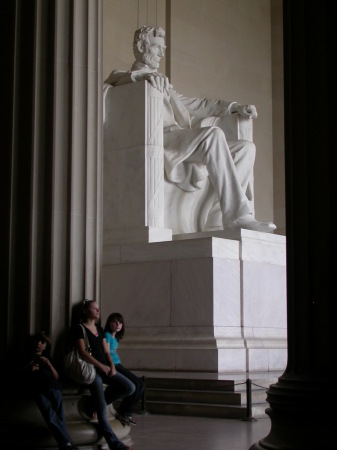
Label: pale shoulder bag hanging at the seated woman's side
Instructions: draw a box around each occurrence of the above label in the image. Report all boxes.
[64,325,96,384]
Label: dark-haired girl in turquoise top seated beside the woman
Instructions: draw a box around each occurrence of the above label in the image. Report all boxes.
[104,313,145,425]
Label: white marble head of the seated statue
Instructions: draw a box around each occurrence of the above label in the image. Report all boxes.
[133,26,166,69]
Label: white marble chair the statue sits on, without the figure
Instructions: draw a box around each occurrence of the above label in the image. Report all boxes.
[103,81,253,244]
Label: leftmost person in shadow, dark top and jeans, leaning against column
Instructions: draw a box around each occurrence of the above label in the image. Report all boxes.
[24,331,77,450]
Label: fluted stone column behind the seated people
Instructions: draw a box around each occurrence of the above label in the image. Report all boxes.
[0,0,128,449]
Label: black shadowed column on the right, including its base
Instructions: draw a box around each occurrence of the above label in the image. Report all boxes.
[251,0,336,450]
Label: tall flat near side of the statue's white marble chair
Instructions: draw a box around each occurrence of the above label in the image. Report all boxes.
[103,83,172,244]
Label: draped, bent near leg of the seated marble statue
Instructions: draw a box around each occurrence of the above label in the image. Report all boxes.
[164,127,276,233]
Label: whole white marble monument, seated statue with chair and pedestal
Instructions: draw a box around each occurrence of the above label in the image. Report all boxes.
[101,29,286,373]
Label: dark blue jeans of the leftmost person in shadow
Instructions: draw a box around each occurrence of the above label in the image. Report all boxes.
[35,388,71,448]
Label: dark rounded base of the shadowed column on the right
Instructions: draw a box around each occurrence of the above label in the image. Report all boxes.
[249,377,336,450]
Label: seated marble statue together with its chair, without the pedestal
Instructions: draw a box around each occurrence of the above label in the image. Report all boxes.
[104,27,275,243]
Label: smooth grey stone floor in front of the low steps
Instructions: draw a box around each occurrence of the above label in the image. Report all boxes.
[115,413,270,450]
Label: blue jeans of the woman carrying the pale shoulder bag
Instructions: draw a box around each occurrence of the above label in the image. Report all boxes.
[88,372,135,449]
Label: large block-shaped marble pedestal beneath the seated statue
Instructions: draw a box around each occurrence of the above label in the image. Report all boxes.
[101,230,287,373]
